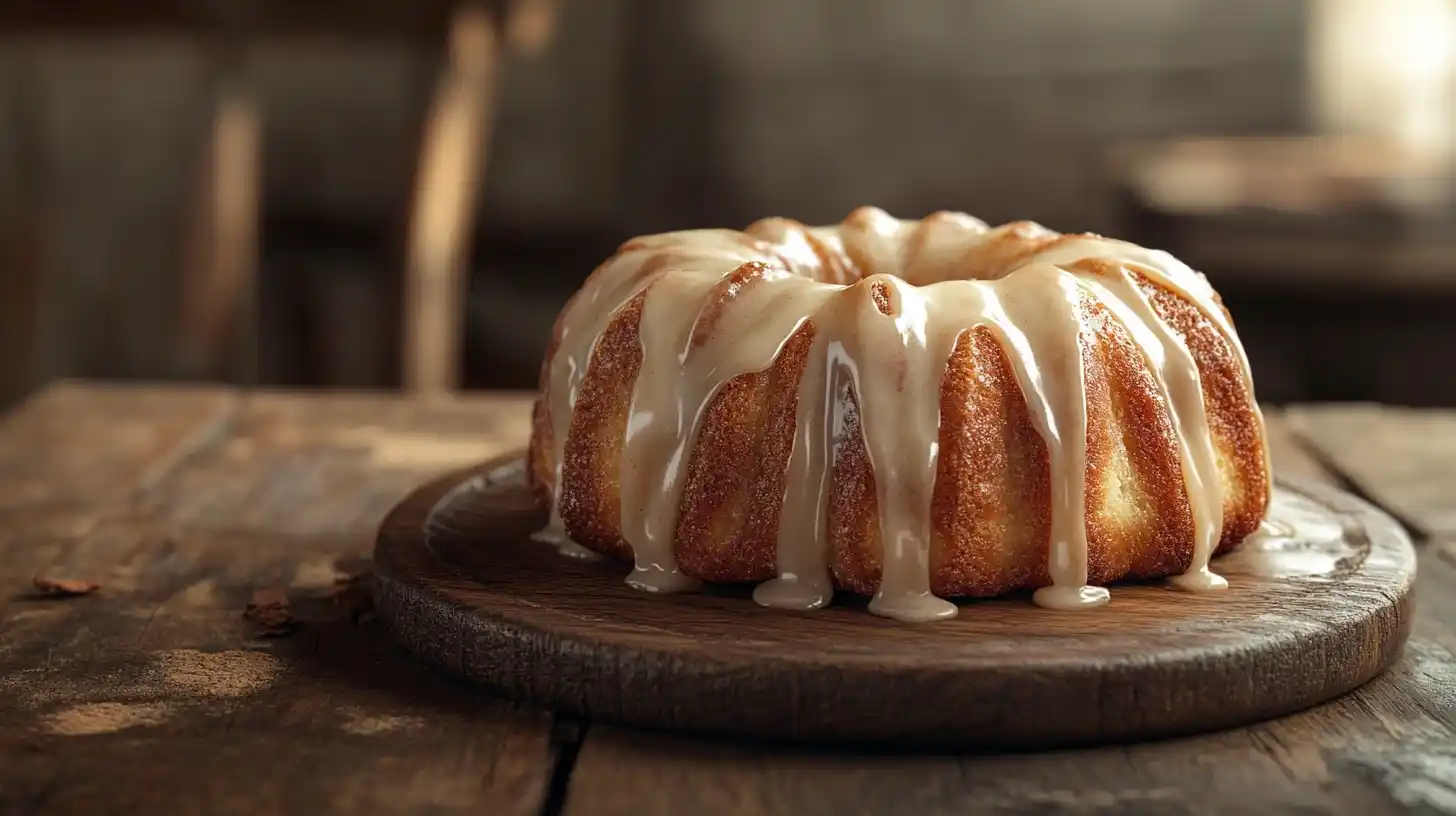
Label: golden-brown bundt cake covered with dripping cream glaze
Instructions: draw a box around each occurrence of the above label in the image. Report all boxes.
[529,207,1271,621]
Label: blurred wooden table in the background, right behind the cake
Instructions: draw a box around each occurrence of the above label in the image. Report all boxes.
[1109,137,1456,405]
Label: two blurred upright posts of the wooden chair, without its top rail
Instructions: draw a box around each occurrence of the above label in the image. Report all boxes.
[168,0,558,396]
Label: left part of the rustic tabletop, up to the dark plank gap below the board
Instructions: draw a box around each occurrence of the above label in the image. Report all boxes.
[0,386,556,815]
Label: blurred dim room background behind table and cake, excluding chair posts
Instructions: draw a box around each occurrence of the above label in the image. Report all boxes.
[0,0,1456,404]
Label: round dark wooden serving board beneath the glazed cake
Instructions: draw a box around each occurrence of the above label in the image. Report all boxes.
[376,451,1415,748]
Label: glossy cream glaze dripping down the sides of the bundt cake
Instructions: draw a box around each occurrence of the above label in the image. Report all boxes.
[536,207,1268,621]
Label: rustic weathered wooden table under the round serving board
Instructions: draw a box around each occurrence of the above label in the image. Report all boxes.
[0,385,1456,816]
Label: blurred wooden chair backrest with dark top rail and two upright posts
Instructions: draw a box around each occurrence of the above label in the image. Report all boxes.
[0,0,559,395]
